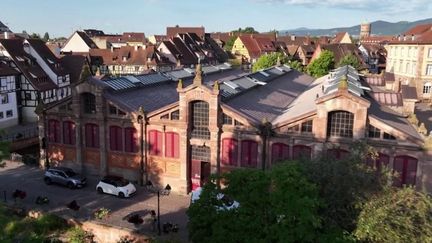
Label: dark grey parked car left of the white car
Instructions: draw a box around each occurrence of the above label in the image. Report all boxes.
[44,167,87,189]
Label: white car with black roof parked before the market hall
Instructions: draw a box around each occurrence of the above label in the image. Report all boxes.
[96,176,136,198]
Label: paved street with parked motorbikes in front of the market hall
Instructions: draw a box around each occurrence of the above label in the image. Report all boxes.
[0,162,190,241]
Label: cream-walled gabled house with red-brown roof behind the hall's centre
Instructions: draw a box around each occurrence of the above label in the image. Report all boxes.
[231,35,276,63]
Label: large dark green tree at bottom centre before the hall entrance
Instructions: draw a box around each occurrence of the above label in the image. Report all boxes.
[187,162,321,242]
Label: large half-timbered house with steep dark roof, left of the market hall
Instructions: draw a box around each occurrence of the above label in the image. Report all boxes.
[0,39,85,123]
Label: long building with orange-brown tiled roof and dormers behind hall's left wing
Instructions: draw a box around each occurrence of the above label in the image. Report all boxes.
[89,45,175,75]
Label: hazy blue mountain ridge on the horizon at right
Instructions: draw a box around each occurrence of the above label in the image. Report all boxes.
[279,18,432,36]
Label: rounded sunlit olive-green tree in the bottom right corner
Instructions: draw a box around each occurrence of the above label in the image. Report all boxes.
[355,187,432,243]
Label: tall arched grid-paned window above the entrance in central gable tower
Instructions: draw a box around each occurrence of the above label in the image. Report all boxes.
[191,100,210,139]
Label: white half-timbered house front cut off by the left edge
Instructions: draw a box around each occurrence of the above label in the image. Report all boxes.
[0,60,20,129]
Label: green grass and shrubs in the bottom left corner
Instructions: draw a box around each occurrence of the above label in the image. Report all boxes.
[0,203,92,243]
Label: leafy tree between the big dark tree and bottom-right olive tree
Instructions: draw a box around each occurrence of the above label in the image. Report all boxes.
[302,142,391,233]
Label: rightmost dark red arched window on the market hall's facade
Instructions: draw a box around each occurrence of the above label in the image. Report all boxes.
[393,155,418,186]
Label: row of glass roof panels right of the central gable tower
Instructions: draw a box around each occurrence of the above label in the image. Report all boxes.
[220,65,291,98]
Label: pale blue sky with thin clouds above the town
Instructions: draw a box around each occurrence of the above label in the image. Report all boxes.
[0,0,432,37]
